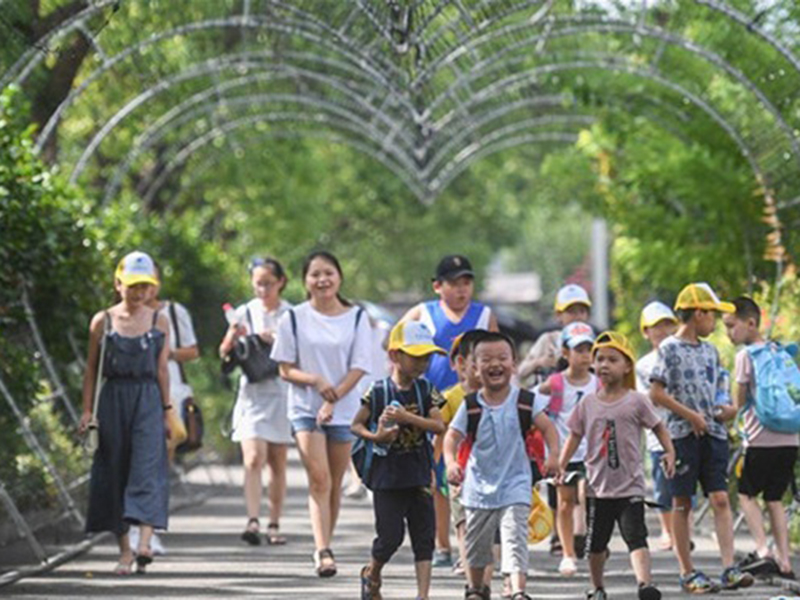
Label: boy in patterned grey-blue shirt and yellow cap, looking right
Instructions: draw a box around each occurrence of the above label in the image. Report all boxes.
[650,283,753,594]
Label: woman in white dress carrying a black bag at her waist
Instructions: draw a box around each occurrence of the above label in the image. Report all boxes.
[219,258,292,546]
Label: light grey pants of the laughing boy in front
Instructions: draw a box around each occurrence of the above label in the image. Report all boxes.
[464,504,531,573]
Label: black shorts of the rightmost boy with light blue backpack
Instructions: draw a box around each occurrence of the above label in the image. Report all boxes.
[739,446,797,502]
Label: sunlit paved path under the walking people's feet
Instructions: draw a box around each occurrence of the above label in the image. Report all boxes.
[0,454,796,600]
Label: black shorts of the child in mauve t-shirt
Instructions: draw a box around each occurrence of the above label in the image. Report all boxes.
[586,496,647,554]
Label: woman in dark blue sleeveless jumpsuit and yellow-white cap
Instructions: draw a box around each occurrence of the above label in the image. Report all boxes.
[81,252,169,575]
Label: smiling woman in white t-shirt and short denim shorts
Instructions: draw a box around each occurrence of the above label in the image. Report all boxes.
[272,251,372,577]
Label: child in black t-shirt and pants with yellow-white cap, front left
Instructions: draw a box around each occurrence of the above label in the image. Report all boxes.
[351,321,446,600]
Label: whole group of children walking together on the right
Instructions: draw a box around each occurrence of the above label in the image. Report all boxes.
[352,256,798,600]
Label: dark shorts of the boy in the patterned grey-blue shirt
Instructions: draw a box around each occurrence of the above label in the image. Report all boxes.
[669,434,730,499]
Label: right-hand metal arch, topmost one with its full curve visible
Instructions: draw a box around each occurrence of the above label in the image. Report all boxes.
[430,18,800,165]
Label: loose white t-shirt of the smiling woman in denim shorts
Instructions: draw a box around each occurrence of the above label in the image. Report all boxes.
[272,302,373,426]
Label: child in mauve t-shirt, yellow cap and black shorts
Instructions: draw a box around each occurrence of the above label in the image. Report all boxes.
[559,331,675,600]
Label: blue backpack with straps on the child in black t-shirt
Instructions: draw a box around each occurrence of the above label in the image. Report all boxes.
[351,377,433,489]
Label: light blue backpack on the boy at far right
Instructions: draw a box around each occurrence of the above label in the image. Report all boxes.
[747,341,800,433]
